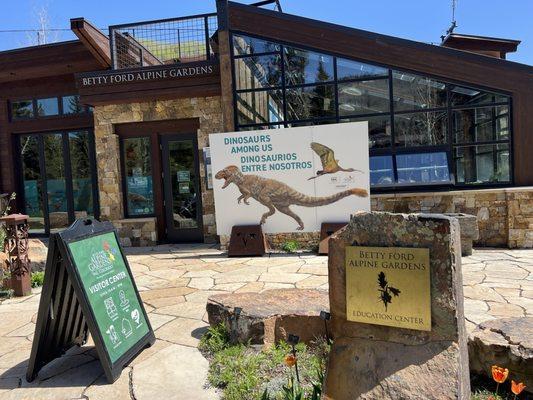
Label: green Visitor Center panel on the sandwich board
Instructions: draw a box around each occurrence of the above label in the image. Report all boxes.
[68,232,149,363]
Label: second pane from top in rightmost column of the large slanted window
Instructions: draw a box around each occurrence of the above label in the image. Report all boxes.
[452,106,509,143]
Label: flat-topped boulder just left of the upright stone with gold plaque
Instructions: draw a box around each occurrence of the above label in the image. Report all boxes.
[206,289,329,346]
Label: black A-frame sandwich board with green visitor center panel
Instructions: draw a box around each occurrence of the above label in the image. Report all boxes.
[26,219,155,383]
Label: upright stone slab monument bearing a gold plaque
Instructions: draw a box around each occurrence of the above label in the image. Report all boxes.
[324,212,470,400]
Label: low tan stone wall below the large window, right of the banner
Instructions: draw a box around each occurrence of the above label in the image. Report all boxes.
[371,187,533,248]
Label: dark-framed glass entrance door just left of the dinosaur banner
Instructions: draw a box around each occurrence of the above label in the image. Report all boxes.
[161,134,204,242]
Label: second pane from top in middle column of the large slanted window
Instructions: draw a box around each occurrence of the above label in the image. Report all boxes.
[338,79,390,116]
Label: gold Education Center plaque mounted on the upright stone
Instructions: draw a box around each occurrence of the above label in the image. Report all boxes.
[346,246,431,331]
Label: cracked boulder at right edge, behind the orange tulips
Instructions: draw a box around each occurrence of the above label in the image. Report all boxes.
[468,317,533,392]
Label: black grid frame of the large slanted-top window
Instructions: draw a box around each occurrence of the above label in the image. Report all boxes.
[230,30,514,193]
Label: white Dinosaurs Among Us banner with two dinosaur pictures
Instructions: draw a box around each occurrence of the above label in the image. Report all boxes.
[209,122,370,235]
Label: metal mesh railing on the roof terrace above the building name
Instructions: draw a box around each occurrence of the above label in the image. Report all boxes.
[109,14,217,69]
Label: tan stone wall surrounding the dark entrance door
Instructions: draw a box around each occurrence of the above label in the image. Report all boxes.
[94,96,223,244]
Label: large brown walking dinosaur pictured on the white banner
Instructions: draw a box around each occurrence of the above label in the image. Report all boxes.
[215,165,368,230]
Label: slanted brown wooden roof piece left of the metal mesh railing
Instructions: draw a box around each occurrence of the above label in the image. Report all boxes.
[70,18,111,68]
